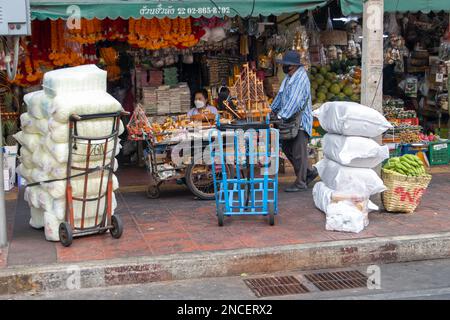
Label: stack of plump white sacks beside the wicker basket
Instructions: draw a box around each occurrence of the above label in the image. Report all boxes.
[313,102,392,233]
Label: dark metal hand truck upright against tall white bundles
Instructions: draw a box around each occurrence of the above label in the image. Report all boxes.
[59,111,129,247]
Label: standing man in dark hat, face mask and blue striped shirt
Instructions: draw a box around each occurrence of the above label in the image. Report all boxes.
[271,51,318,192]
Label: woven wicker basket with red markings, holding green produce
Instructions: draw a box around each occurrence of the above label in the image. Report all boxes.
[381,169,431,213]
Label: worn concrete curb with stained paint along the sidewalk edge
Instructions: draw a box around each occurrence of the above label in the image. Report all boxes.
[0,232,450,295]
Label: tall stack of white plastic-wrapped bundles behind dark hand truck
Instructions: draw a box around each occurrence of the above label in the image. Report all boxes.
[15,65,124,241]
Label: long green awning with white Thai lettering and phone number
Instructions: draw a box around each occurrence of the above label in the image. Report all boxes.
[31,0,327,20]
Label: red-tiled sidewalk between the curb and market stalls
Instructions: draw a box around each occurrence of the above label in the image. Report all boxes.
[0,166,450,292]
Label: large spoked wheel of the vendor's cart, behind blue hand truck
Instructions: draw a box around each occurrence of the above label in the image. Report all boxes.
[185,164,230,200]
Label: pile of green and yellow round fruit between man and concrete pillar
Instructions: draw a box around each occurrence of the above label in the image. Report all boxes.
[309,62,361,104]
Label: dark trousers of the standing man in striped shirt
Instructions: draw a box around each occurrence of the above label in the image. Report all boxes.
[281,130,313,188]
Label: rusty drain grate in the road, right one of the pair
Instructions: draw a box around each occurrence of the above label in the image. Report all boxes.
[305,270,367,291]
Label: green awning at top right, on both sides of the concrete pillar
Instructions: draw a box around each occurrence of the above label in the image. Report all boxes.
[340,0,450,16]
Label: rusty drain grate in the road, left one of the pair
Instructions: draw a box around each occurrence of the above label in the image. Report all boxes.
[244,276,309,298]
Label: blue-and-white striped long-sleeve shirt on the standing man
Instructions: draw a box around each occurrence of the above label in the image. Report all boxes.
[271,67,313,137]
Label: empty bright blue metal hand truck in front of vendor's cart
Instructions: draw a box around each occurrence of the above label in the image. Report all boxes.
[209,118,279,226]
